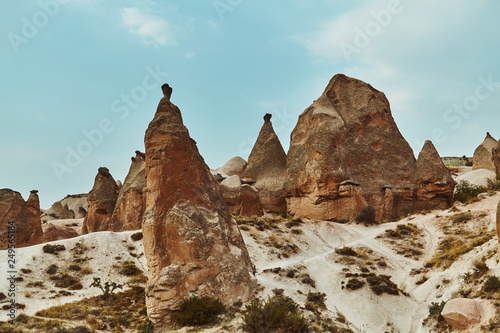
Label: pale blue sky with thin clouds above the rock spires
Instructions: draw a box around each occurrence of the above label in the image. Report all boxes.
[0,0,500,208]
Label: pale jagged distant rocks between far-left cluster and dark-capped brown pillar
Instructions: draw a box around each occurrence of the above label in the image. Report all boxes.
[42,193,88,223]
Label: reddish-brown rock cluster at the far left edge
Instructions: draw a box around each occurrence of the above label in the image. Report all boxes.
[0,189,43,250]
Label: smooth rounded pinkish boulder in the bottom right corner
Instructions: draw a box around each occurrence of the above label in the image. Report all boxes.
[441,298,484,330]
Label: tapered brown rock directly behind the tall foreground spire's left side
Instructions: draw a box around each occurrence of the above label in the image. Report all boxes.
[106,151,146,231]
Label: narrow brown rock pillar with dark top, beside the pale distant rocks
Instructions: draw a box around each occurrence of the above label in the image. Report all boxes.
[82,167,119,234]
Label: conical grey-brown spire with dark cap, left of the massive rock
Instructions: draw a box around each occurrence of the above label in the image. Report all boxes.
[245,113,286,213]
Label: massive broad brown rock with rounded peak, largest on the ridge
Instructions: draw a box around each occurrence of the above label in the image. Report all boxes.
[284,74,416,220]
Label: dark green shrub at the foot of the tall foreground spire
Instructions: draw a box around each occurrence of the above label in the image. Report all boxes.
[172,296,226,327]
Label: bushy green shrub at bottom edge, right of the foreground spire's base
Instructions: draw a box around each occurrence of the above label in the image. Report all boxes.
[243,295,309,333]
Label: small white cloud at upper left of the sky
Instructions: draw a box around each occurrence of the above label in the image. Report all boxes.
[121,8,177,46]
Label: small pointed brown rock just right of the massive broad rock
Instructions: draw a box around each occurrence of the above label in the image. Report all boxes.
[415,140,455,209]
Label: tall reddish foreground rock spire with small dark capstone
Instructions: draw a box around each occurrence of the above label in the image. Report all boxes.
[143,84,255,331]
